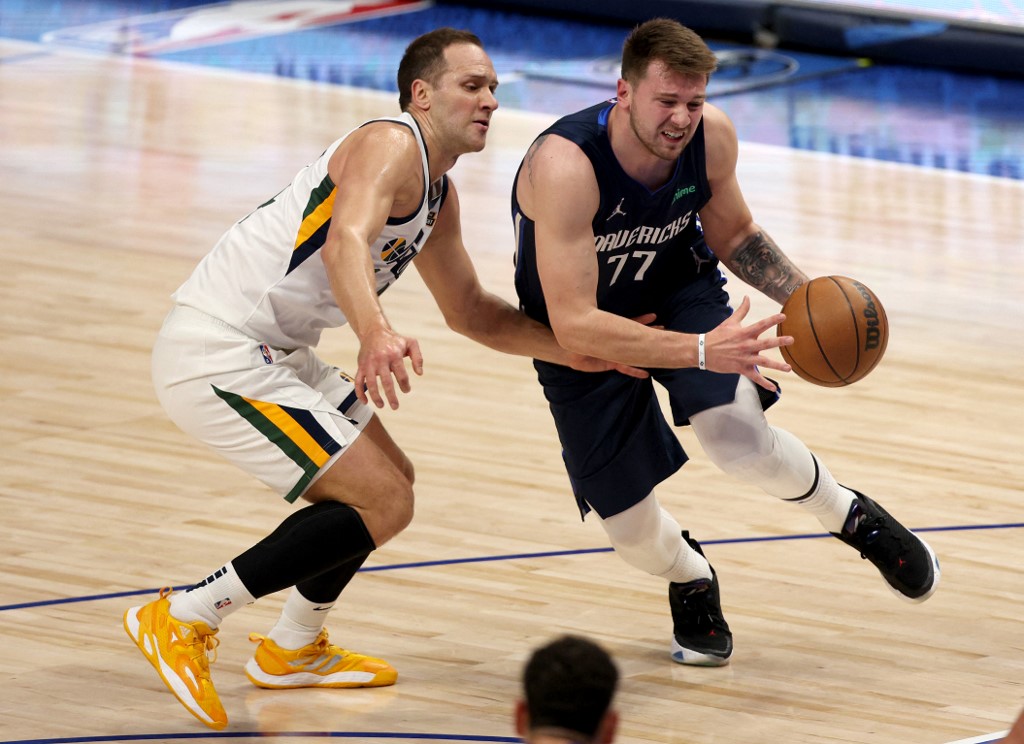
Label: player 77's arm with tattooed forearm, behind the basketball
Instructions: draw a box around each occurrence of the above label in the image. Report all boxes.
[700,104,808,304]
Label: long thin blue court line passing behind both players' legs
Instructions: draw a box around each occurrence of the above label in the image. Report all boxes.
[0,522,1024,614]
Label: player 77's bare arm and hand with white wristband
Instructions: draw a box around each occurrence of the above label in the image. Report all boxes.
[517,135,787,388]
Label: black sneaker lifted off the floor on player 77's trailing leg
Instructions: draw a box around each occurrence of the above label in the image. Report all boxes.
[833,491,941,602]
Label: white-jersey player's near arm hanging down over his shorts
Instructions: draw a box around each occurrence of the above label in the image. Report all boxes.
[321,123,423,408]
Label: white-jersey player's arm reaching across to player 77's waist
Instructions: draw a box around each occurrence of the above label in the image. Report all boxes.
[413,178,647,377]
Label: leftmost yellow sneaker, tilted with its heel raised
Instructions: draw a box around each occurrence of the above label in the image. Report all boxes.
[125,588,227,730]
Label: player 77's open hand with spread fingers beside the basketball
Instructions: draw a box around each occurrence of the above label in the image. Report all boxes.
[705,297,793,392]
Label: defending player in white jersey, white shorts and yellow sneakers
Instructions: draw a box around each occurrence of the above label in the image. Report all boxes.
[124,29,675,729]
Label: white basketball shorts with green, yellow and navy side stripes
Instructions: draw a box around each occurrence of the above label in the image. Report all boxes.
[153,305,374,501]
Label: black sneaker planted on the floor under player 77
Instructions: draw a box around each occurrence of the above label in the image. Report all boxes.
[669,531,732,666]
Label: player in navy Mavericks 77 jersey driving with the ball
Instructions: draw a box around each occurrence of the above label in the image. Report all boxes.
[512,18,939,665]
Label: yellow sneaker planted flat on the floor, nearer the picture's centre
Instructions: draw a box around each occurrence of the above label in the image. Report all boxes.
[246,630,398,690]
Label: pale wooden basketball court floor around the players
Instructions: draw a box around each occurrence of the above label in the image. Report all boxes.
[0,43,1024,744]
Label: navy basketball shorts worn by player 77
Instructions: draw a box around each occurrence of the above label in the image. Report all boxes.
[534,271,777,518]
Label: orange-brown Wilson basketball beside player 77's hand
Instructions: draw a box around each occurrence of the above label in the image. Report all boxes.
[778,276,889,388]
